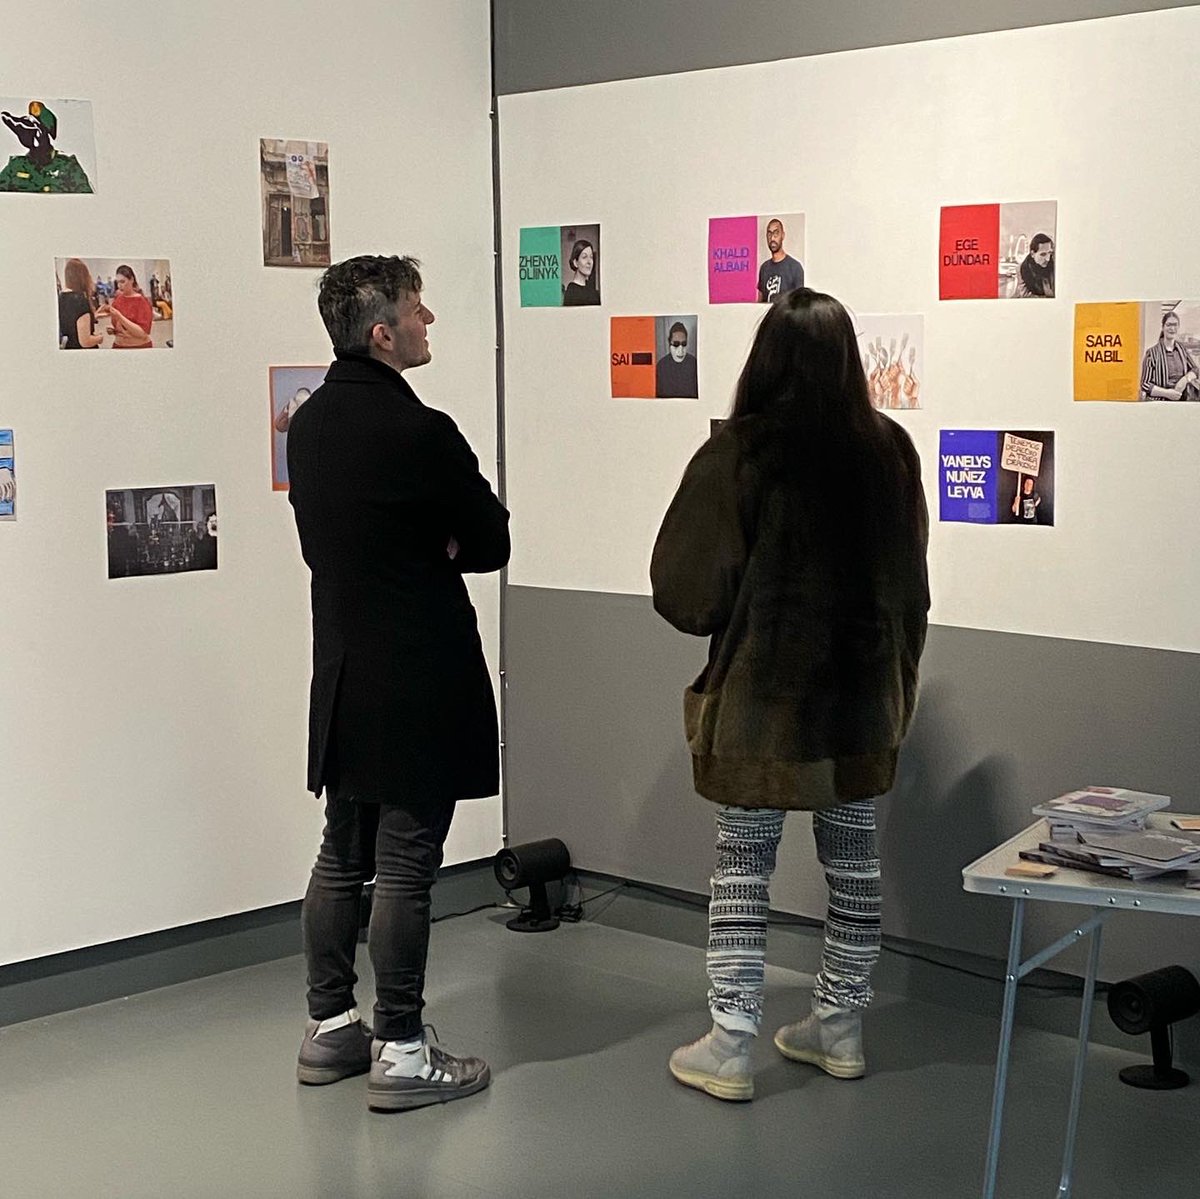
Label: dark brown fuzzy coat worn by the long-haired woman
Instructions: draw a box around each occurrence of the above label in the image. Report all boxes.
[650,414,929,810]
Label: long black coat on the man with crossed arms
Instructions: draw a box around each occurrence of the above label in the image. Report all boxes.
[288,354,509,803]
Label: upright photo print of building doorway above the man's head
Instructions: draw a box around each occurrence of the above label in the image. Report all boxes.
[258,137,332,266]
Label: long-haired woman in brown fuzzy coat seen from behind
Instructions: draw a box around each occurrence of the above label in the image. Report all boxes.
[650,288,929,1099]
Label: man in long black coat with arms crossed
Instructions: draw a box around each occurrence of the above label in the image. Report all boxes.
[288,257,509,1110]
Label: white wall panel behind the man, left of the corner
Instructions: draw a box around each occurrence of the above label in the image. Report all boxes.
[0,0,500,964]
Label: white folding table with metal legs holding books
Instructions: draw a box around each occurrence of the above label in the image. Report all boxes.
[962,813,1200,1199]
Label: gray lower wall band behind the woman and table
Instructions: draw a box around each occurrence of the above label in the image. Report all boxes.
[506,587,1200,979]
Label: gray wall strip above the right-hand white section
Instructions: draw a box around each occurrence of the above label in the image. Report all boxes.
[493,0,1190,96]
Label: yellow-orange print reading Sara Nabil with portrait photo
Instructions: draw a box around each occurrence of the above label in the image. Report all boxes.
[1074,300,1200,403]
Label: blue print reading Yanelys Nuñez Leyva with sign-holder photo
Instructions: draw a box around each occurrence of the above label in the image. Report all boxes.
[937,428,1055,526]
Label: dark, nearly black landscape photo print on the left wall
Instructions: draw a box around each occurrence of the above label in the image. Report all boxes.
[104,484,217,578]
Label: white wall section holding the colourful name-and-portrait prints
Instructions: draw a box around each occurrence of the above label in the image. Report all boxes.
[500,7,1200,651]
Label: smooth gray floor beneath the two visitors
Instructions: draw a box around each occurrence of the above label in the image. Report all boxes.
[0,912,1200,1199]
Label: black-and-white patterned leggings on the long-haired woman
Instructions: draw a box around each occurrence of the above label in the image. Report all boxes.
[707,799,881,1032]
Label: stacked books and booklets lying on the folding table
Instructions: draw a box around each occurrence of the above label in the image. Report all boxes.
[1021,787,1200,879]
